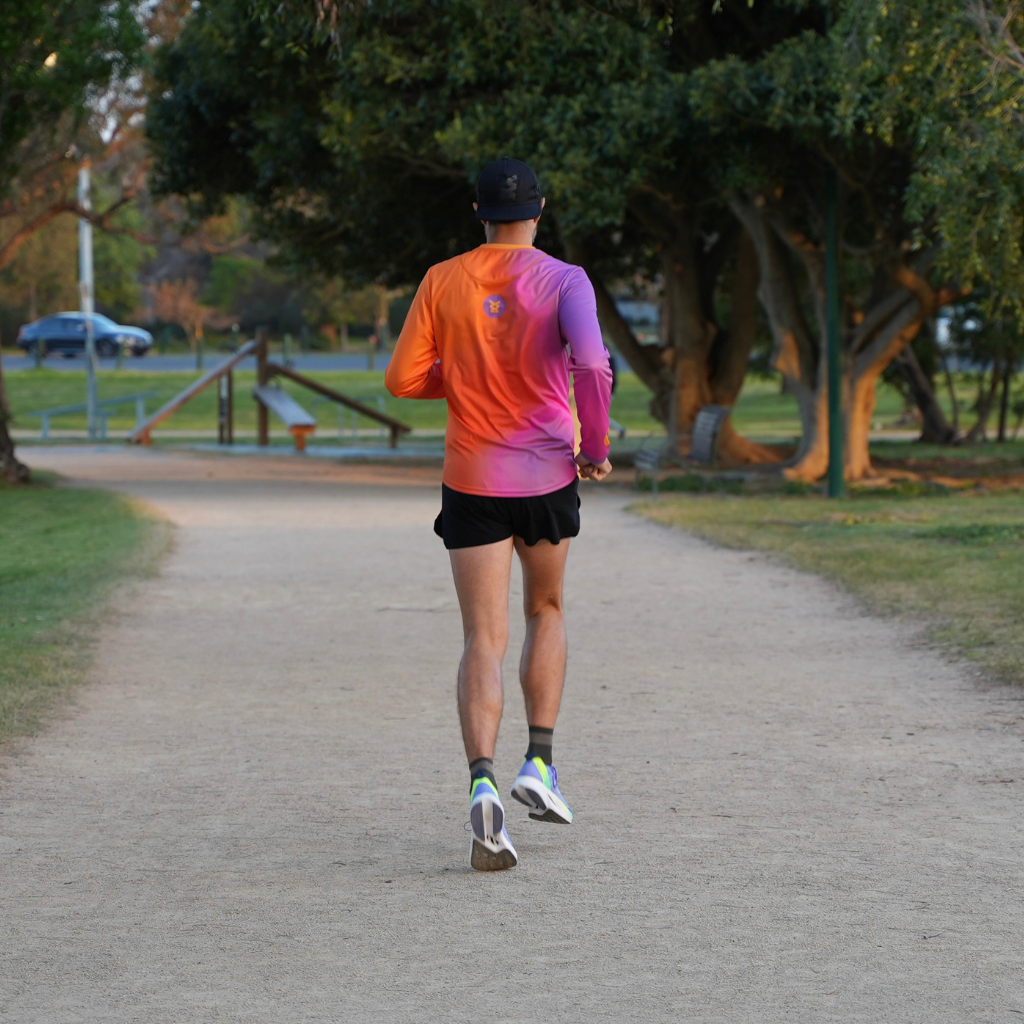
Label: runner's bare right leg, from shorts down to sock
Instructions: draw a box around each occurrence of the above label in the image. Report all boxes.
[515,538,569,729]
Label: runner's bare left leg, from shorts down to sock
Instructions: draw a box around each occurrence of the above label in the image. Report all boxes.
[449,539,512,762]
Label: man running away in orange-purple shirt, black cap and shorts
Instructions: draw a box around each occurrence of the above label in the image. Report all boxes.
[384,160,611,871]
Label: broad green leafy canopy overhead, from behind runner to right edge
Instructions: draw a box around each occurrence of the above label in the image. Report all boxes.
[150,0,1021,299]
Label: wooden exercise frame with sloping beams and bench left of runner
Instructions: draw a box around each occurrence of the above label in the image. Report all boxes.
[127,328,412,452]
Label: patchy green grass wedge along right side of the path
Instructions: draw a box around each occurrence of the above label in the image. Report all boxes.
[635,494,1024,683]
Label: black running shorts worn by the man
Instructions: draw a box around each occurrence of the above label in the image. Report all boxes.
[434,480,580,550]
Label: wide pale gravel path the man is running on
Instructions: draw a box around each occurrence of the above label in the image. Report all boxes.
[0,452,1024,1024]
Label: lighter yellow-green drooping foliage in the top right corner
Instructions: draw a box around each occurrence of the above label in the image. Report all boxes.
[834,0,1024,308]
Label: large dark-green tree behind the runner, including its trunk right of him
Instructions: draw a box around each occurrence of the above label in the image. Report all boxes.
[148,0,815,461]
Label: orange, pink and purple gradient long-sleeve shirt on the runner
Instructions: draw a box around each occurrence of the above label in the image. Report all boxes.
[384,244,611,498]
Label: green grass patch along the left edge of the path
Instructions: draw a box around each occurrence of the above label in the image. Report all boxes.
[0,476,169,742]
